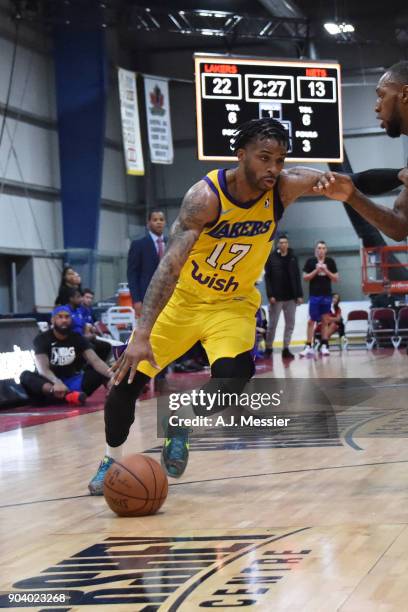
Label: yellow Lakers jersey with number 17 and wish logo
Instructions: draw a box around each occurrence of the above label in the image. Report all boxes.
[177,169,283,302]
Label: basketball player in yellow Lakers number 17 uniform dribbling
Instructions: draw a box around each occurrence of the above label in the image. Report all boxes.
[89,119,323,495]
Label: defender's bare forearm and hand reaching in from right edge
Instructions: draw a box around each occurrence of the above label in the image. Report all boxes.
[314,171,408,241]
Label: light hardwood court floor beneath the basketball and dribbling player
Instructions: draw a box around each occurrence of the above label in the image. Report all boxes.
[0,351,408,612]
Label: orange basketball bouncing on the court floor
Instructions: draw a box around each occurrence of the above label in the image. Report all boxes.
[103,455,168,516]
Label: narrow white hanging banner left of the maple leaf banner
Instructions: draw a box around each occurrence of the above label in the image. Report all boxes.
[118,68,144,175]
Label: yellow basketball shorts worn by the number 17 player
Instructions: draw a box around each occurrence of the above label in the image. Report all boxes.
[137,289,258,378]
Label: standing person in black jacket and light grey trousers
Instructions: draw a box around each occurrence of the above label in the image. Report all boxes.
[265,236,303,359]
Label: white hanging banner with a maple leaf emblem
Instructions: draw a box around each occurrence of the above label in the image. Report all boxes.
[144,76,173,164]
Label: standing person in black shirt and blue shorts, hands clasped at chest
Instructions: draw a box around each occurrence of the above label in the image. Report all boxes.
[300,240,339,357]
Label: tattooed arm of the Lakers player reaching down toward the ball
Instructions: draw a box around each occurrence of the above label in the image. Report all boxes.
[112,181,219,384]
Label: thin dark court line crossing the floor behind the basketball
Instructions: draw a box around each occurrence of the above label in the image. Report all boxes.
[0,459,408,510]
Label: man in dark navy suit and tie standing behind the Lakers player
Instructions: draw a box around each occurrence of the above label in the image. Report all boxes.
[127,210,166,317]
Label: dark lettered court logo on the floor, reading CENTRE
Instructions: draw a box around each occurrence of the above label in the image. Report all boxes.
[7,528,311,612]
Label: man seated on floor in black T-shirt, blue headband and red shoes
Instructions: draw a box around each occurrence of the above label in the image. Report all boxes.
[20,306,111,406]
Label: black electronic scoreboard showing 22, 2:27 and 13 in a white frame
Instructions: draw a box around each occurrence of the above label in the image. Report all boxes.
[194,53,343,162]
